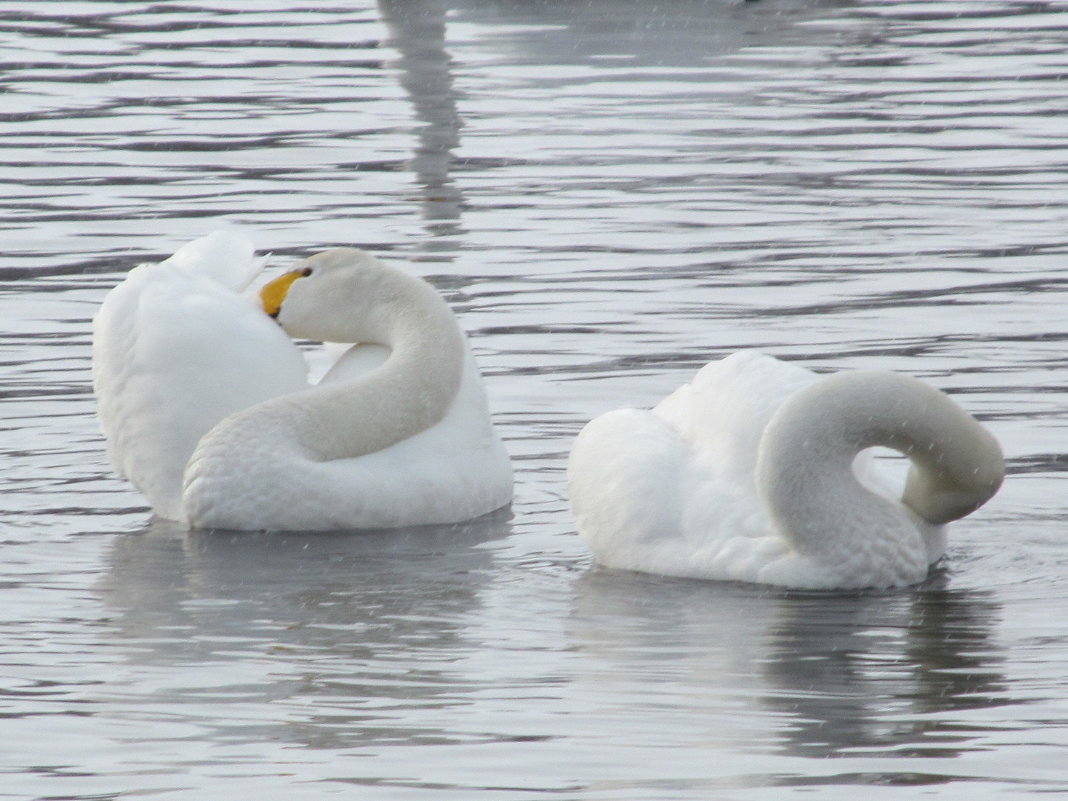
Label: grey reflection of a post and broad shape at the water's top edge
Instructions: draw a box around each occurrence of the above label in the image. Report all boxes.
[378,0,852,261]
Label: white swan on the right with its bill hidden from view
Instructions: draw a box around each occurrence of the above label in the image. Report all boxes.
[568,351,1004,588]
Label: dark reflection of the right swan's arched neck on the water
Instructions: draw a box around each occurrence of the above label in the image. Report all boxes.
[763,581,1012,757]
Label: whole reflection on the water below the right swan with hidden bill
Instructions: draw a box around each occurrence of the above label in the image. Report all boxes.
[570,569,1011,767]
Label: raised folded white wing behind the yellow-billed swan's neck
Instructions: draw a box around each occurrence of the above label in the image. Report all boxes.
[93,263,307,519]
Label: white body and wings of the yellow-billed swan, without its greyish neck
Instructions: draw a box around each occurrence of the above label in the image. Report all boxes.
[93,232,512,530]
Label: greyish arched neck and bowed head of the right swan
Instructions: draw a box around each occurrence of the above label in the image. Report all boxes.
[757,371,1004,559]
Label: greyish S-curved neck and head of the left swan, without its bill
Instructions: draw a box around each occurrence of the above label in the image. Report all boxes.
[239,257,466,461]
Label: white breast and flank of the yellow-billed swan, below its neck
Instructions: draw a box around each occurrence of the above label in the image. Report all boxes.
[179,357,512,531]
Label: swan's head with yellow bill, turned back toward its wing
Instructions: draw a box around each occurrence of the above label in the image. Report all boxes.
[260,248,390,342]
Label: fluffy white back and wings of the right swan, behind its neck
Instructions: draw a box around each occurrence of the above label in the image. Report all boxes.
[568,351,803,581]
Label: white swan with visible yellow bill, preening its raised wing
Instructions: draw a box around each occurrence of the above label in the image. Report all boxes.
[93,232,513,531]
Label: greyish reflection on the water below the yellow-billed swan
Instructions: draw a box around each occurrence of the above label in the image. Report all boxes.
[97,513,512,749]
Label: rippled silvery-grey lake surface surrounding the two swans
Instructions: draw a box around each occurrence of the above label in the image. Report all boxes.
[0,0,1068,801]
